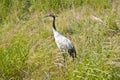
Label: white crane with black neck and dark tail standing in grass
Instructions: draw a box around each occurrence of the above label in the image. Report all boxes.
[45,13,76,61]
